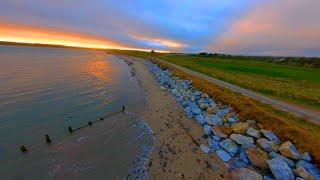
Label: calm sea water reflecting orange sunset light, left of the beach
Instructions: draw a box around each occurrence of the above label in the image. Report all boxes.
[0,46,153,179]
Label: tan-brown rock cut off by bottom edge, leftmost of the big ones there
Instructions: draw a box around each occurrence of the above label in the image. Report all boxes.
[231,168,262,180]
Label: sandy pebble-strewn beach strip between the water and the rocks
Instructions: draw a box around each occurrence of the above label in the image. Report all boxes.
[129,58,229,179]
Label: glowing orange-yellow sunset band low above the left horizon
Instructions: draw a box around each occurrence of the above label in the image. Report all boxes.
[0,22,165,51]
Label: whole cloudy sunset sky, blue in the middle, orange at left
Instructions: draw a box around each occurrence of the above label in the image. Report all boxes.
[0,0,320,56]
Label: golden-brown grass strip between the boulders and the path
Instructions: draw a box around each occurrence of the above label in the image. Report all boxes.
[154,61,320,164]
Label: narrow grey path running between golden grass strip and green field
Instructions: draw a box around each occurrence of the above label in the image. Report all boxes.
[149,58,320,124]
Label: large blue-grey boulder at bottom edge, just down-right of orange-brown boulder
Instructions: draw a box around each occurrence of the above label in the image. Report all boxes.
[268,158,295,180]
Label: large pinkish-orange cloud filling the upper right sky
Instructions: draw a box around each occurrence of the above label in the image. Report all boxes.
[208,0,320,55]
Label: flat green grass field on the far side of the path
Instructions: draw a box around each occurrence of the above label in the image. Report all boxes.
[109,51,320,110]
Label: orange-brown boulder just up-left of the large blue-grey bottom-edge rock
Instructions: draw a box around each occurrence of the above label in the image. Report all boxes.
[246,148,268,169]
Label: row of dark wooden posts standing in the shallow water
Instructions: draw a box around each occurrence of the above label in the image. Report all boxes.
[20,106,125,153]
